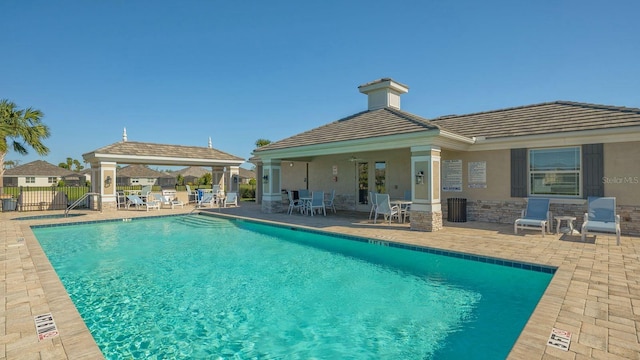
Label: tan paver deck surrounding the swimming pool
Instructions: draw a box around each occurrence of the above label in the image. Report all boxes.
[0,203,640,359]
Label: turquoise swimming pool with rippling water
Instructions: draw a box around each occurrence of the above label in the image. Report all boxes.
[34,215,553,359]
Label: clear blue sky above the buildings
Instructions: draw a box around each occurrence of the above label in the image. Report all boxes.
[5,0,640,168]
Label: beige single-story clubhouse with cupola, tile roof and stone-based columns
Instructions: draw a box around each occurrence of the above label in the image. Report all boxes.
[252,78,640,234]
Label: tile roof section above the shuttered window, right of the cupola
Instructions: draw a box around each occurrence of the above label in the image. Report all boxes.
[431,101,640,138]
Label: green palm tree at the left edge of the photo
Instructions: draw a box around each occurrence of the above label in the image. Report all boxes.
[0,99,51,193]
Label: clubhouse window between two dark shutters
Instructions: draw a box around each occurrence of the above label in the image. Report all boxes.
[529,147,581,196]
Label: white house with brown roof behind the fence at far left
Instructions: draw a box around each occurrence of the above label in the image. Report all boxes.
[4,160,85,186]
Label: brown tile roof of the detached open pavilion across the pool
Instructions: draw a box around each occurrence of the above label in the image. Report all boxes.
[83,141,244,161]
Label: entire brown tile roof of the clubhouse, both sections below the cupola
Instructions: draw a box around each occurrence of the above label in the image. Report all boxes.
[254,101,640,155]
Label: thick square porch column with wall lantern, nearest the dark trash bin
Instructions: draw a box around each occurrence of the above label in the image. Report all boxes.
[410,146,442,231]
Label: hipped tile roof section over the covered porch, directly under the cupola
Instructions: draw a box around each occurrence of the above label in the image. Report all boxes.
[254,107,438,153]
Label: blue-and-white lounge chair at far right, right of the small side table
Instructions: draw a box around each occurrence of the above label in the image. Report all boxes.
[581,197,620,245]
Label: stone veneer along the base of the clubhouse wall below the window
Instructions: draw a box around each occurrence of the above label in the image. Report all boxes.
[442,200,640,235]
